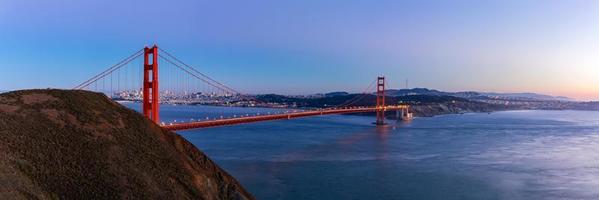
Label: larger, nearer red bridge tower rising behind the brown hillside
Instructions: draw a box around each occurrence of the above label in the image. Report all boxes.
[143,45,160,123]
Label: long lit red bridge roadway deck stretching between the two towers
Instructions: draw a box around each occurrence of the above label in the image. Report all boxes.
[162,105,408,131]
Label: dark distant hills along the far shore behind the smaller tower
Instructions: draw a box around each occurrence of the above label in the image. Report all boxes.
[257,88,599,116]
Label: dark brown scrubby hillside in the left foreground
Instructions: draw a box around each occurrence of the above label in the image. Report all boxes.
[0,90,253,199]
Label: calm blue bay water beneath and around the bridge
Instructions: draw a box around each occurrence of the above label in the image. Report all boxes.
[123,103,599,200]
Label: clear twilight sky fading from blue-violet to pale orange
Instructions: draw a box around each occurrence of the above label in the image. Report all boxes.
[0,0,599,100]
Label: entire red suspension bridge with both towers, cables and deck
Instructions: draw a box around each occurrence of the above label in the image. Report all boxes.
[74,45,411,131]
